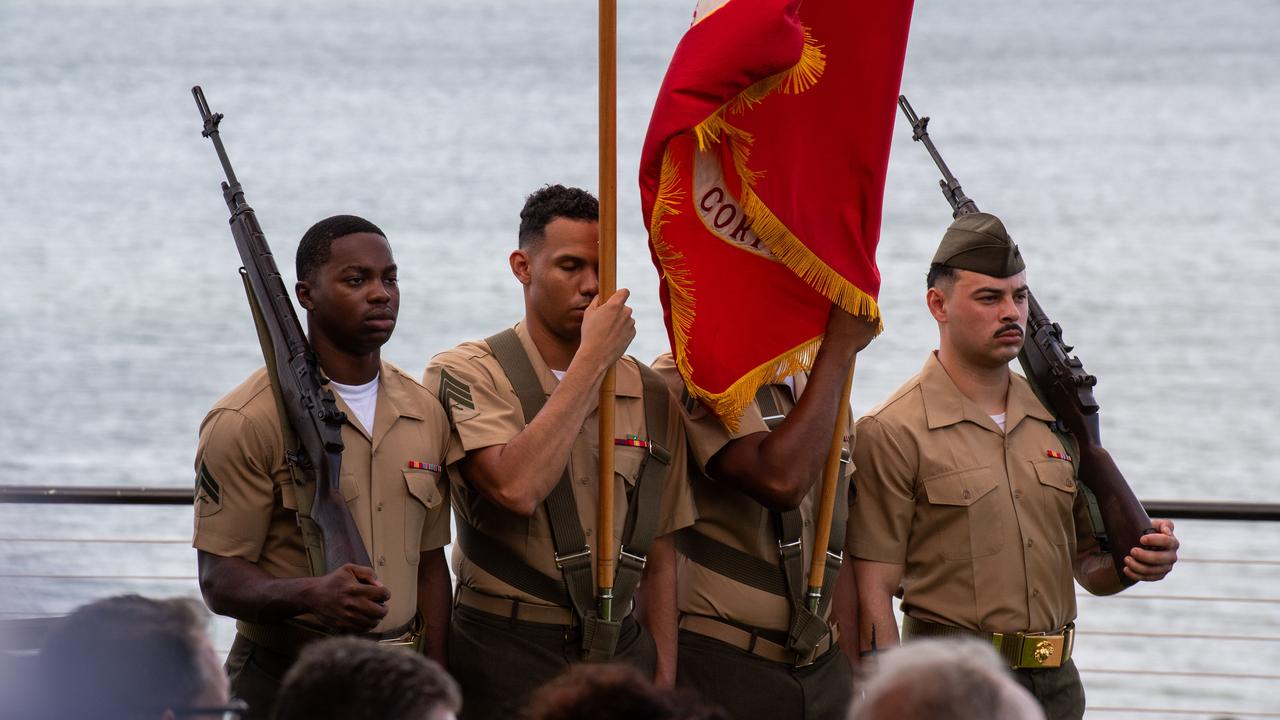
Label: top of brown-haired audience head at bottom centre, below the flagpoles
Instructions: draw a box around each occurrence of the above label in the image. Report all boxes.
[524,662,728,720]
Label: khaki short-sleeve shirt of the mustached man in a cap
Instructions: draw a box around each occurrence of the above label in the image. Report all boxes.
[847,354,1097,633]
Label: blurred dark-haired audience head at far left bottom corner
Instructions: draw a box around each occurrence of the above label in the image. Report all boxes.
[40,594,209,719]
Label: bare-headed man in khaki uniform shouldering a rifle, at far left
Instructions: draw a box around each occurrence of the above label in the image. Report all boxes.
[193,215,451,717]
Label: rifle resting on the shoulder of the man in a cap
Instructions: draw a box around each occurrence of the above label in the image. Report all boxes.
[897,95,1156,584]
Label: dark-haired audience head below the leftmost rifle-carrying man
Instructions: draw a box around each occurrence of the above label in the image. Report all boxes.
[273,638,462,720]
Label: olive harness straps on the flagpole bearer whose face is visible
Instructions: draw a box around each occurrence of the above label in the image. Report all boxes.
[458,328,672,660]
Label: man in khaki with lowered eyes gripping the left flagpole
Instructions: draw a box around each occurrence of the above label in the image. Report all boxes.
[425,186,696,720]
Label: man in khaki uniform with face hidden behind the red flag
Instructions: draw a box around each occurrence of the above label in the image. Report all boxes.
[654,309,874,720]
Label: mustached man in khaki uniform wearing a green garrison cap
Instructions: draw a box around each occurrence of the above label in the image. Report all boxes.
[849,213,1178,719]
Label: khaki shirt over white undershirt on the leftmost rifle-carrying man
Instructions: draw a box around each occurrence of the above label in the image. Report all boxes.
[192,363,449,632]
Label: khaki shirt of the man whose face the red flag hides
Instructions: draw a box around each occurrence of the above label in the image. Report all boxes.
[653,352,850,630]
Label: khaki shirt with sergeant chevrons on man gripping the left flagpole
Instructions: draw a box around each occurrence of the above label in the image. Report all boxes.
[424,323,698,605]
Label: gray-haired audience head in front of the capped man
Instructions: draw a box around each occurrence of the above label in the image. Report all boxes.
[849,639,1044,720]
